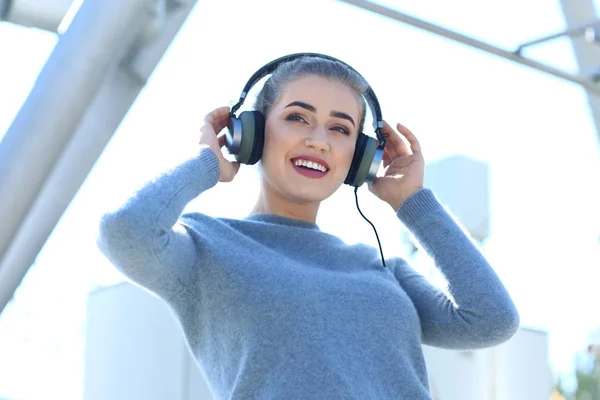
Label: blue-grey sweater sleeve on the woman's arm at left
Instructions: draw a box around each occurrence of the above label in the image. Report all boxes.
[97,147,219,299]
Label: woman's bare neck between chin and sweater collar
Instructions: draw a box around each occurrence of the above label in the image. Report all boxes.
[250,182,320,224]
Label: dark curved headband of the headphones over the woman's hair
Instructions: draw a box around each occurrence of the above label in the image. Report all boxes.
[231,53,386,150]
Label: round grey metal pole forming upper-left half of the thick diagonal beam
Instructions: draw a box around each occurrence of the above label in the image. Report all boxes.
[0,0,154,311]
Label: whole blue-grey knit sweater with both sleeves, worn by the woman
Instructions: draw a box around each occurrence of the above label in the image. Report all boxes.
[98,148,519,400]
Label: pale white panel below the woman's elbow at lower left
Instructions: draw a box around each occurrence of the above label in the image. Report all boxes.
[84,283,213,400]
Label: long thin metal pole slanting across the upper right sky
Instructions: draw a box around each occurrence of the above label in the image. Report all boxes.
[339,0,600,95]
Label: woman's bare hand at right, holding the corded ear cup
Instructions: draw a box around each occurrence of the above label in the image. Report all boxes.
[369,121,425,211]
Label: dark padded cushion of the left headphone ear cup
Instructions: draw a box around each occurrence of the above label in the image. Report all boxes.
[235,111,265,165]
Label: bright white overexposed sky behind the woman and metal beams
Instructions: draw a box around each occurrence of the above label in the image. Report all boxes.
[0,0,600,399]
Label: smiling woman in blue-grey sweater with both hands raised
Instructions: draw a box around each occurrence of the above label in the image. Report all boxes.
[99,57,519,400]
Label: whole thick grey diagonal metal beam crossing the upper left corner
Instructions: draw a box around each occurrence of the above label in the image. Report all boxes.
[0,0,202,312]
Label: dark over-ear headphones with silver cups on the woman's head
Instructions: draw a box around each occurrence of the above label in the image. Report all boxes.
[225,53,386,187]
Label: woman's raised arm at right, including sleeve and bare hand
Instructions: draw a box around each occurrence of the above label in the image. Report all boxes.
[370,123,519,348]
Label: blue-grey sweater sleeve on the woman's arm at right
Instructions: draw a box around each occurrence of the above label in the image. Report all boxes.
[394,189,519,349]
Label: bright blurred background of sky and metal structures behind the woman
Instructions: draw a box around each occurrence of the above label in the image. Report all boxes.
[0,0,600,400]
